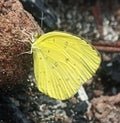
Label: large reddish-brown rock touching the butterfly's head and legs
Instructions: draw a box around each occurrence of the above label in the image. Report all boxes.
[0,0,42,88]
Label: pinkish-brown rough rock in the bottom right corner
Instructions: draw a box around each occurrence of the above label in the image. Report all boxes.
[91,93,120,123]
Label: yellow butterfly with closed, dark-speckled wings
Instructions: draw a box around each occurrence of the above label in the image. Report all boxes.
[32,31,101,100]
